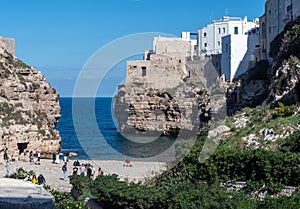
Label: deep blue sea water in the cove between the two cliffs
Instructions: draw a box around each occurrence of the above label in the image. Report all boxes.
[56,98,175,161]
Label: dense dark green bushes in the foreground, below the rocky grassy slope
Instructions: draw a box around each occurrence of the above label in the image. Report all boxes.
[66,121,300,209]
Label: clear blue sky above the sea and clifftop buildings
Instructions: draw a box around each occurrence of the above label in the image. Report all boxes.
[0,0,265,96]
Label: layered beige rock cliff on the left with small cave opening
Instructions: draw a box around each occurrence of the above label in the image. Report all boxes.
[0,48,61,162]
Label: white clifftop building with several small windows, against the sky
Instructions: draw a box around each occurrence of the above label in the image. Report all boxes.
[198,16,256,57]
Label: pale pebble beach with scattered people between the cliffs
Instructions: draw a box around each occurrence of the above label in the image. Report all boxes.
[0,159,166,192]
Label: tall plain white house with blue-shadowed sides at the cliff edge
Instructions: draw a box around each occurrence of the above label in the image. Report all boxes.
[221,27,260,81]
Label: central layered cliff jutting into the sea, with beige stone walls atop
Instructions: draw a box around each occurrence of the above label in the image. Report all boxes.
[114,54,225,138]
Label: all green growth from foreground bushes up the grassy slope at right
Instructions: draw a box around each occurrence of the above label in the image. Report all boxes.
[63,98,300,209]
